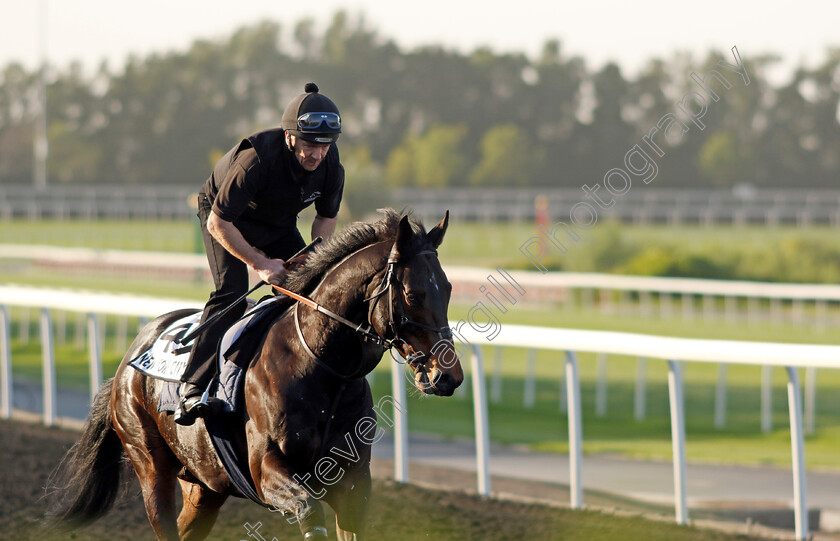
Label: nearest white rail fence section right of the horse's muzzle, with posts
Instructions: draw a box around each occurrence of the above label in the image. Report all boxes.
[450,325,840,539]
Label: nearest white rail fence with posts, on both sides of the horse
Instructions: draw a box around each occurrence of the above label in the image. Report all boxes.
[0,286,840,540]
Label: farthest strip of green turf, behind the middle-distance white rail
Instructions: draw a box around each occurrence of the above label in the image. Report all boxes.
[6,215,840,271]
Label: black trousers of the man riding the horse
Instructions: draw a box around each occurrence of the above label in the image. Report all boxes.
[181,193,306,388]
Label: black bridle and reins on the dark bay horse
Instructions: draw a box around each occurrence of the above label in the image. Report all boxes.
[288,245,452,381]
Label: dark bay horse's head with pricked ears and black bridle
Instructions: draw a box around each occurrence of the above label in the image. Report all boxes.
[371,211,464,396]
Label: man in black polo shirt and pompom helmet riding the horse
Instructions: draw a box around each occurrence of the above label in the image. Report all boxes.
[175,83,344,426]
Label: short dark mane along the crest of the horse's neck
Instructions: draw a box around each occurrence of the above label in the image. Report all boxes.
[283,208,428,295]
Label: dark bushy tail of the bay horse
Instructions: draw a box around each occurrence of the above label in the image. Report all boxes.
[47,378,124,525]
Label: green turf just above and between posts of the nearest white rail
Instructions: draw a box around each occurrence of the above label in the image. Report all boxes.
[3,300,840,467]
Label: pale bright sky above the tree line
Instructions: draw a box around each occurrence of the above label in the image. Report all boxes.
[0,0,840,81]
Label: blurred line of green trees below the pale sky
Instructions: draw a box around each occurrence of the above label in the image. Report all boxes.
[0,11,840,189]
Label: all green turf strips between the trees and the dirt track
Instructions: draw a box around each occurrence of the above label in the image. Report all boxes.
[0,221,840,468]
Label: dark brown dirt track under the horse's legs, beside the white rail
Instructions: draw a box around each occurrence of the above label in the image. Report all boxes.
[0,421,776,541]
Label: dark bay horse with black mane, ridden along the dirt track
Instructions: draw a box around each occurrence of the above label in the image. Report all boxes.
[53,210,463,541]
